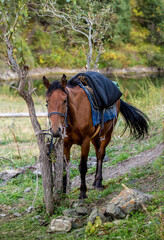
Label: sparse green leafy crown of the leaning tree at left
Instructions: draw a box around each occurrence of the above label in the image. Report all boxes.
[0,0,30,68]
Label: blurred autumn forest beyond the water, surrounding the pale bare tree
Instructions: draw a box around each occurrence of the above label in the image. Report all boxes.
[0,0,164,70]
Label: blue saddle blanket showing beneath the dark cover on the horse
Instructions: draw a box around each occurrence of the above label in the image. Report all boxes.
[78,83,117,126]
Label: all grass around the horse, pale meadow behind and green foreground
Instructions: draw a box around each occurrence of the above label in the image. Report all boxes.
[0,78,164,240]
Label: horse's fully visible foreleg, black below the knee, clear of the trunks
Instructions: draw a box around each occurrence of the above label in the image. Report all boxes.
[79,139,90,199]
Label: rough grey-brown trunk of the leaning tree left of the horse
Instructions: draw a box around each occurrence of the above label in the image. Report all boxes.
[5,36,54,214]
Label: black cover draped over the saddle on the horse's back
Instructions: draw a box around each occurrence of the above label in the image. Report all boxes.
[69,71,122,109]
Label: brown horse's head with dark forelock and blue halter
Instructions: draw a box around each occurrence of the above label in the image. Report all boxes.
[43,74,68,137]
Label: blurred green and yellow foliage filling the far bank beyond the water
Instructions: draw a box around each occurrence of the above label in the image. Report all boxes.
[0,0,164,68]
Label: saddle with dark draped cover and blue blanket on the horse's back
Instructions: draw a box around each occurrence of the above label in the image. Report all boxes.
[68,71,122,129]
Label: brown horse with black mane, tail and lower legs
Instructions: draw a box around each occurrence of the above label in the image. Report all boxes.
[43,74,148,199]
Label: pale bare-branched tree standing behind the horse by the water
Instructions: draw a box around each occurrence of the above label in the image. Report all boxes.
[38,0,111,70]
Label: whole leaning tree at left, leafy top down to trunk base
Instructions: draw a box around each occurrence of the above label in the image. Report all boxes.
[0,0,54,214]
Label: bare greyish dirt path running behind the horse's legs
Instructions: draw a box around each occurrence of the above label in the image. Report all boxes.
[72,143,164,188]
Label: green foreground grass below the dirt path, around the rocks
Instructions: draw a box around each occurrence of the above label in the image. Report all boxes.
[0,158,164,240]
